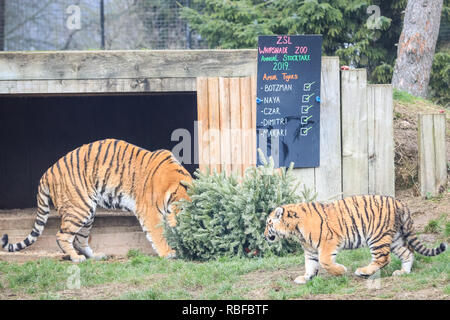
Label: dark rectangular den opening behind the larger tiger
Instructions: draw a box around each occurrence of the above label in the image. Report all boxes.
[0,92,197,209]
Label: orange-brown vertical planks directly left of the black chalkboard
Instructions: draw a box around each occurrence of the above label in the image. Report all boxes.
[197,77,256,175]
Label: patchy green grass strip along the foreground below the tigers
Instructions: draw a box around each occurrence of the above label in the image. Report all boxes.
[0,245,450,300]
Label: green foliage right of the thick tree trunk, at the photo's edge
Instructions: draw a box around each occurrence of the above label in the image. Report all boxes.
[430,49,450,105]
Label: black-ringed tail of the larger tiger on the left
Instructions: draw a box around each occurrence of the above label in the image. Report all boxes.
[1,179,50,252]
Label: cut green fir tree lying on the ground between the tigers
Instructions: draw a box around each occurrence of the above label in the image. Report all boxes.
[165,154,312,260]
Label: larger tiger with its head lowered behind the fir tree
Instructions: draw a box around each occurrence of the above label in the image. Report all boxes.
[2,139,192,263]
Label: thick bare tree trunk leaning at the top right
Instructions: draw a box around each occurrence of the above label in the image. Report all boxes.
[392,0,443,98]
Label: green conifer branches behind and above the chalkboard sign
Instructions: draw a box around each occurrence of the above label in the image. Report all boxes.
[181,0,407,83]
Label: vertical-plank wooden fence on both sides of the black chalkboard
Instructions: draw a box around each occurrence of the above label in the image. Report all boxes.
[197,57,395,201]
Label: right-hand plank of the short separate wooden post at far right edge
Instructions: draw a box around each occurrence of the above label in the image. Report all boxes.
[433,114,447,191]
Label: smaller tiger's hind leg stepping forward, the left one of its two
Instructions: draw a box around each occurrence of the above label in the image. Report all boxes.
[355,235,392,277]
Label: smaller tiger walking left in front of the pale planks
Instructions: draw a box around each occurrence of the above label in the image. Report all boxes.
[264,195,447,284]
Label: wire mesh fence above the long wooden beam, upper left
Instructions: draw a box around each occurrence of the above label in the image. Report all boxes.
[0,0,206,51]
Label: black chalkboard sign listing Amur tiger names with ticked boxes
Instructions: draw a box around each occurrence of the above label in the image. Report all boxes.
[256,35,322,168]
